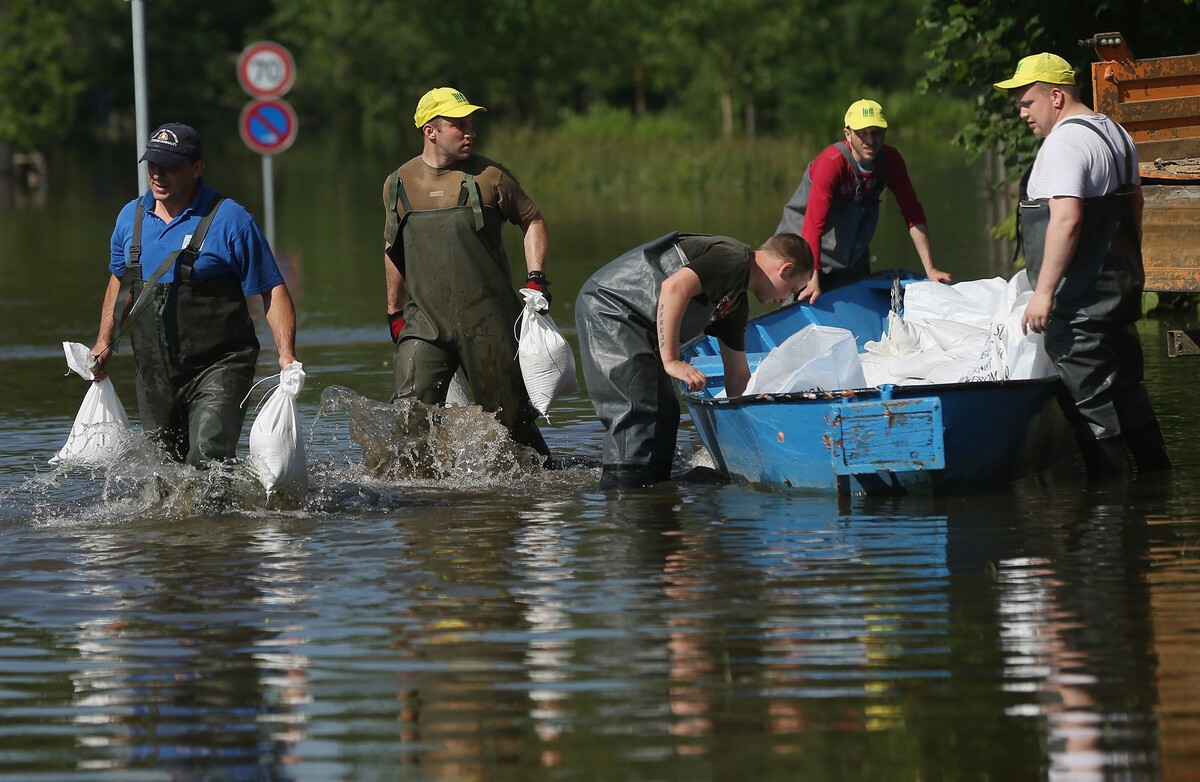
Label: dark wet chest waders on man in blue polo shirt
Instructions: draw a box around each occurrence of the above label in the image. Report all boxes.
[114,196,258,465]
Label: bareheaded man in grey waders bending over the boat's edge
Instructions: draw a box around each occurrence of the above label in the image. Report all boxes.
[575,233,812,489]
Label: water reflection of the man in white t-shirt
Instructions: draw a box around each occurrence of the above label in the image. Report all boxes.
[952,487,1159,780]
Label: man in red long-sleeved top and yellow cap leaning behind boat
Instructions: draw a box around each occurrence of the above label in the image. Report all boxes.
[775,98,950,302]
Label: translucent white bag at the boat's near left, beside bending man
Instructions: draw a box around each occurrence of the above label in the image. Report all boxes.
[745,325,866,393]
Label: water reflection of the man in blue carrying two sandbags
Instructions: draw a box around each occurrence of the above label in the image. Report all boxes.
[5,515,307,780]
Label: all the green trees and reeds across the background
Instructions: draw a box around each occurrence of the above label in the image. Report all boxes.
[0,0,1200,314]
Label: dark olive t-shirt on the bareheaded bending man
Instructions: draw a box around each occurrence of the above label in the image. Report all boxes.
[679,236,751,350]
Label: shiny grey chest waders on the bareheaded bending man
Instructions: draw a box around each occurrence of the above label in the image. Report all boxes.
[575,233,719,483]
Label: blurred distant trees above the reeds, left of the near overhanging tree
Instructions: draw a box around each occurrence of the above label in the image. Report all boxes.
[0,0,925,146]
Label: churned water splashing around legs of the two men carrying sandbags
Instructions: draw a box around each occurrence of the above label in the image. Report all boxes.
[0,386,598,527]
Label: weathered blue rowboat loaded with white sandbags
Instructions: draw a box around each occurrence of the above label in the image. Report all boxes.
[683,271,1073,494]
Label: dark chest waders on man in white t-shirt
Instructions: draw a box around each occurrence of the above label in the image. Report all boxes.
[1019,119,1157,444]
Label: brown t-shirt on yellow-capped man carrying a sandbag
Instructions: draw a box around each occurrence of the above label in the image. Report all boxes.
[383,155,540,251]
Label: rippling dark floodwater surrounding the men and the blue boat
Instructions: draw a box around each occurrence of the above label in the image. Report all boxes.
[0,137,1200,781]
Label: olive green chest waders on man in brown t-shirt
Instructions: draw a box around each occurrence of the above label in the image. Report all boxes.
[388,167,550,455]
